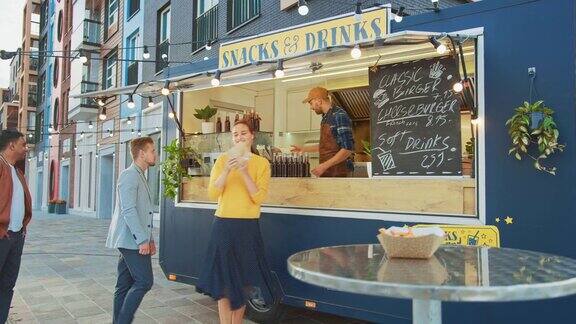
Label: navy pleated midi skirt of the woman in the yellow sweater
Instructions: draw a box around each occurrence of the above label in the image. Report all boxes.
[196,217,275,310]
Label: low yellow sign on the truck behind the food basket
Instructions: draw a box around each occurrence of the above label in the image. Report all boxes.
[414,224,500,247]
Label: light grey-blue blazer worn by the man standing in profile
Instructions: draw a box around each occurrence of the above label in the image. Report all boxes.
[106,163,154,250]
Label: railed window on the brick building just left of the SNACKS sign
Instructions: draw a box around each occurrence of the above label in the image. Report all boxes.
[192,0,218,51]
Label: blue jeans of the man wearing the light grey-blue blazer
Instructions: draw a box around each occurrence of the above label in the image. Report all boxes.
[113,249,154,324]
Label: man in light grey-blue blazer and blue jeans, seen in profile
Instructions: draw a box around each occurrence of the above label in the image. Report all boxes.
[106,137,156,324]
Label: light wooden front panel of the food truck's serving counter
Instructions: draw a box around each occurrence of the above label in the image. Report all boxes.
[182,177,476,217]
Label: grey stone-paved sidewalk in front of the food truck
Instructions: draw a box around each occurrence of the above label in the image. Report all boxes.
[8,212,364,324]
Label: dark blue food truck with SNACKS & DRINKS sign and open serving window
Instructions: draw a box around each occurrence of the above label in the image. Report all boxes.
[79,0,576,323]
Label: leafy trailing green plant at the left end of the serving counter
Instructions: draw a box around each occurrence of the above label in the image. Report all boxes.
[162,139,203,199]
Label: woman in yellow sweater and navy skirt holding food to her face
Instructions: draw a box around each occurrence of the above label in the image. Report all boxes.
[196,120,273,324]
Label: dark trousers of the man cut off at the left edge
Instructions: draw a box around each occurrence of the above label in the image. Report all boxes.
[0,230,24,323]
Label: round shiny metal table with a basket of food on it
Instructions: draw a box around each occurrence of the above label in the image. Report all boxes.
[288,244,576,324]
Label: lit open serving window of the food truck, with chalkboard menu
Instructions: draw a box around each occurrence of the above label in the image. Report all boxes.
[180,39,482,218]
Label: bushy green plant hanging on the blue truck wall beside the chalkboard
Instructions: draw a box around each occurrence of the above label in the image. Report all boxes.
[506,101,566,175]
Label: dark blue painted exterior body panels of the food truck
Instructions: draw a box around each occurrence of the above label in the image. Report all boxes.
[160,0,576,324]
